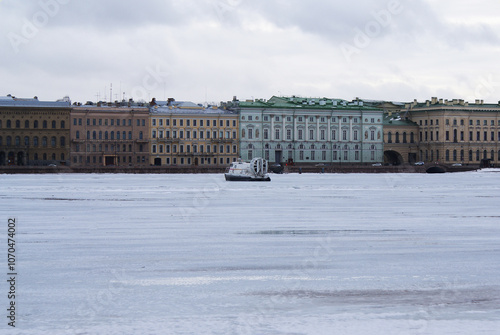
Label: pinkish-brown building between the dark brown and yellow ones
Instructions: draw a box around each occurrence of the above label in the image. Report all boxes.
[71,103,149,167]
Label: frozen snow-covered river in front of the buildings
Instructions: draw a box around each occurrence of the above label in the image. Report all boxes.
[0,171,500,335]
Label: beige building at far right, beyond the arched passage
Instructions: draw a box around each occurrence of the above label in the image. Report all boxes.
[407,98,500,164]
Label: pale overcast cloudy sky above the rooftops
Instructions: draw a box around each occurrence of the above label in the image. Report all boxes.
[0,0,500,103]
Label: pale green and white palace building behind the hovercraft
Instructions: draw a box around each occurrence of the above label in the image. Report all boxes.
[230,97,383,164]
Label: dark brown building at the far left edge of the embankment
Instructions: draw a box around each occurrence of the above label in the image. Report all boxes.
[0,96,71,166]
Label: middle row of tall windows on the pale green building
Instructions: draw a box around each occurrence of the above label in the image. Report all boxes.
[241,128,380,141]
